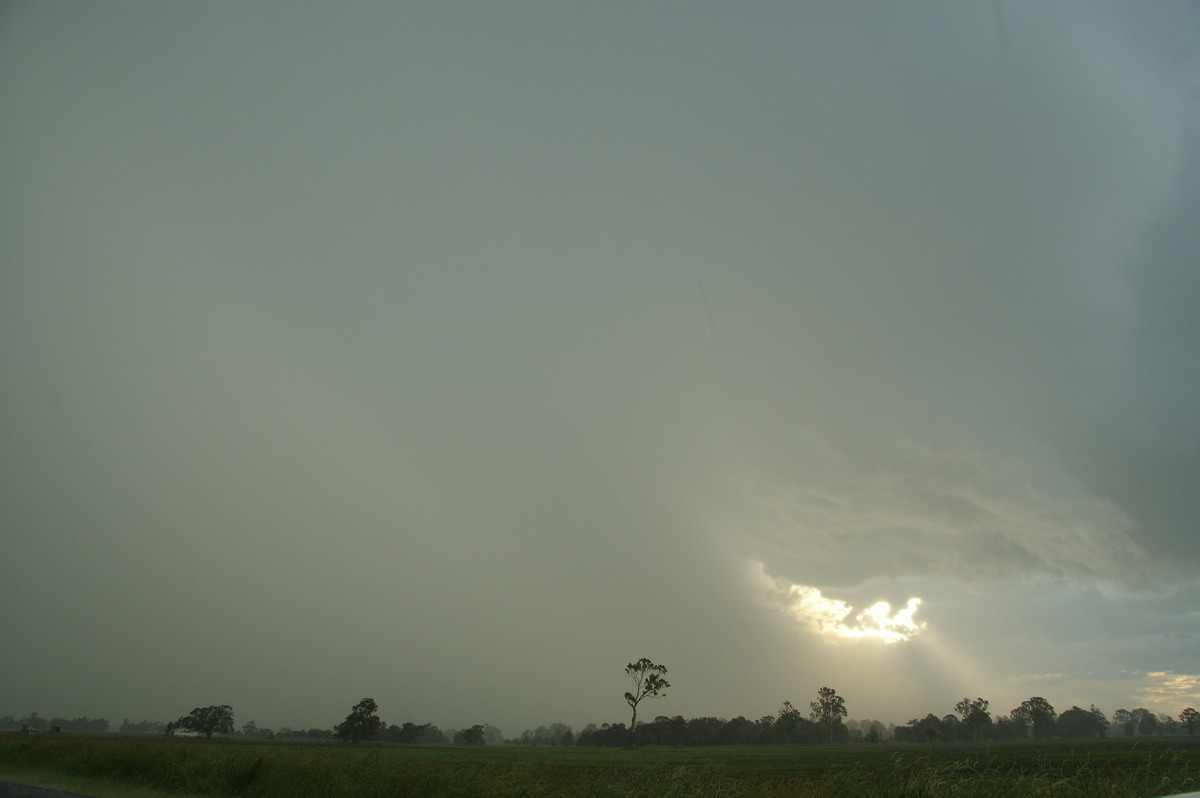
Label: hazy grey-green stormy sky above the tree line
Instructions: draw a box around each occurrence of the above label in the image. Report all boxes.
[0,0,1200,737]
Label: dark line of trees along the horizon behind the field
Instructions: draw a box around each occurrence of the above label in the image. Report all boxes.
[9,658,1200,748]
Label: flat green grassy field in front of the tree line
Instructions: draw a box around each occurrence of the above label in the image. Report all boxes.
[0,734,1200,798]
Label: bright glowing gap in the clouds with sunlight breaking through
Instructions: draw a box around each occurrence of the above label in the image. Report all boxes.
[758,564,925,643]
